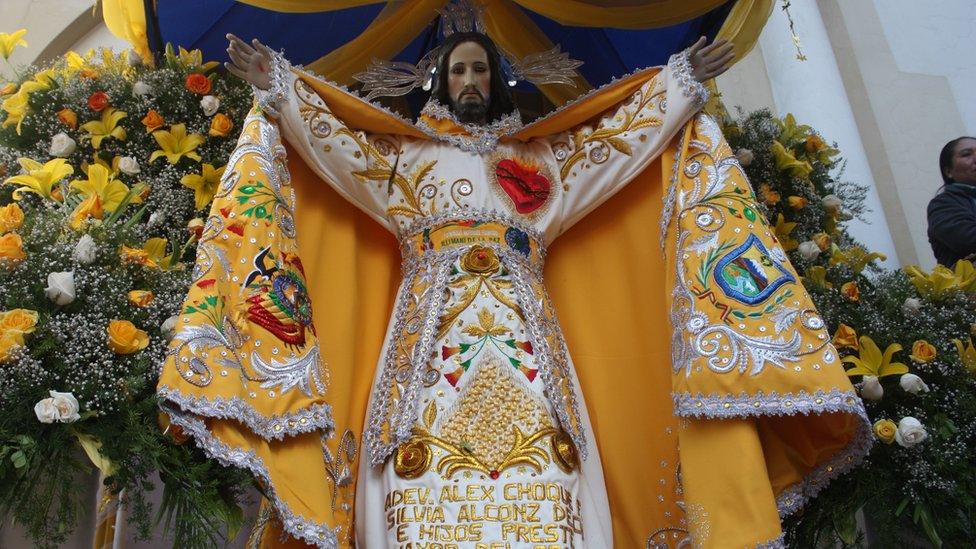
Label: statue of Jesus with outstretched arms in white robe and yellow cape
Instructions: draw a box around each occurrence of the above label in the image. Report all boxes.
[159,25,864,549]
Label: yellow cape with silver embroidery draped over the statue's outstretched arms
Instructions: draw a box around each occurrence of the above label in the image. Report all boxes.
[160,70,871,547]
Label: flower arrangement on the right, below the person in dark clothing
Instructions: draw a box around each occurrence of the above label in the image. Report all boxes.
[724,111,976,548]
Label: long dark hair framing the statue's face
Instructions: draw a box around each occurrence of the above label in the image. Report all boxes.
[430,32,515,123]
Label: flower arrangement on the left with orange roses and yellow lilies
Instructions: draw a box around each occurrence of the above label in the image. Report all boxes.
[0,31,251,547]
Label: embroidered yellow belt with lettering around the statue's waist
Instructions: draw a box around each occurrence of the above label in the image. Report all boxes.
[400,218,546,273]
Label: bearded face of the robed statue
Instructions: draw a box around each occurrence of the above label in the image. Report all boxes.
[447,42,491,123]
